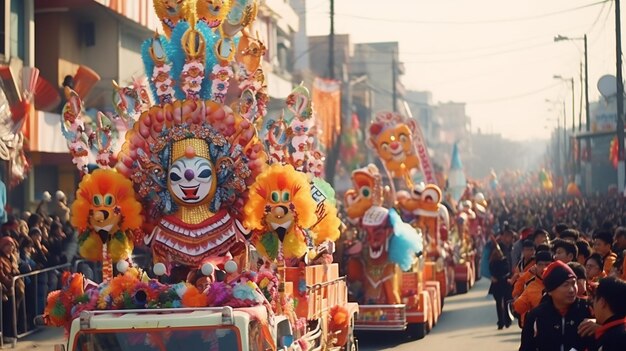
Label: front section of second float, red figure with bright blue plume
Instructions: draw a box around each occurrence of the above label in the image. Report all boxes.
[344,164,428,339]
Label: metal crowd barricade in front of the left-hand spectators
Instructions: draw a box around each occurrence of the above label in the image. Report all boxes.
[9,263,72,339]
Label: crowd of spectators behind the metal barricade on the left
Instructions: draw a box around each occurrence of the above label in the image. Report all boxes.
[0,191,78,338]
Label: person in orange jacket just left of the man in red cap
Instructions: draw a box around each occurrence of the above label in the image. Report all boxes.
[513,251,553,325]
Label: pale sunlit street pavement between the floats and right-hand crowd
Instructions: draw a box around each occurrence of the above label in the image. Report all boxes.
[359,278,521,351]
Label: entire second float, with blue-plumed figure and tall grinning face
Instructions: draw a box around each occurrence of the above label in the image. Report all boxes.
[342,112,485,338]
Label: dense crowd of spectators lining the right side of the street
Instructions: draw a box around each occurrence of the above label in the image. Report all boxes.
[483,193,626,351]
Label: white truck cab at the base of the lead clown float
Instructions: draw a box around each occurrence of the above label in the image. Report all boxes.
[57,306,297,351]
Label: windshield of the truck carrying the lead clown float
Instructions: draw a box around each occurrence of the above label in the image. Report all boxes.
[72,327,241,351]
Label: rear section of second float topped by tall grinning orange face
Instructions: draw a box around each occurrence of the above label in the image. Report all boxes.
[367,112,455,303]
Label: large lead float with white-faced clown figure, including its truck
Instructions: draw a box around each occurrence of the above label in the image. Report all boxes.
[42,0,356,351]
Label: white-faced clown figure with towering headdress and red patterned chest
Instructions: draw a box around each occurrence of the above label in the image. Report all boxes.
[111,0,268,266]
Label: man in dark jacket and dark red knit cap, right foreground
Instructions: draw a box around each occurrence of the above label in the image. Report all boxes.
[519,261,594,351]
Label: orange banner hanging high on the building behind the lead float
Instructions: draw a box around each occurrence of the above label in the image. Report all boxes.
[313,78,341,152]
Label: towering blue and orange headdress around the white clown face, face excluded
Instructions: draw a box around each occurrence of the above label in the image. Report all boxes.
[118,0,266,220]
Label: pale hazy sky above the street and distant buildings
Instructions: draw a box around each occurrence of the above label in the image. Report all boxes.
[307,0,626,140]
